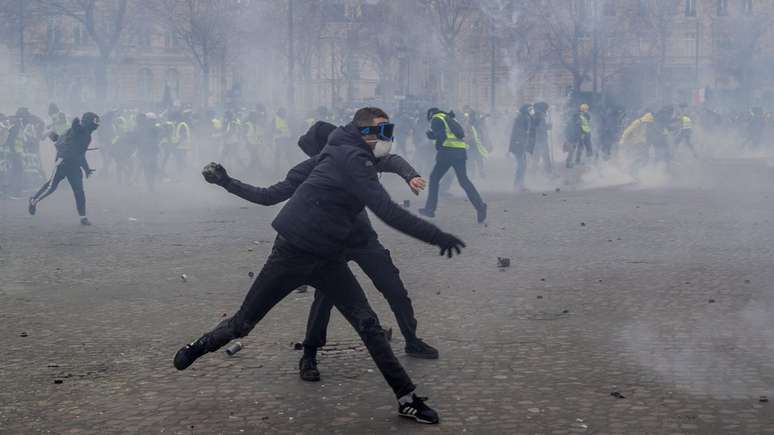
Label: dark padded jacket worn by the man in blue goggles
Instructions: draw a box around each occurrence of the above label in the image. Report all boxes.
[272,124,441,257]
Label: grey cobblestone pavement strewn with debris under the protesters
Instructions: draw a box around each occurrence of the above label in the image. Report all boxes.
[0,160,774,434]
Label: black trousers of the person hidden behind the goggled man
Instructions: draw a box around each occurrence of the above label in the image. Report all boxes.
[304,238,417,349]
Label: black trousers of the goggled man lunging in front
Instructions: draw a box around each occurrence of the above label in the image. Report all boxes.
[193,237,415,397]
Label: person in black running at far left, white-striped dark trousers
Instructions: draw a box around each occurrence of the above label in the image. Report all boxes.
[28,112,99,225]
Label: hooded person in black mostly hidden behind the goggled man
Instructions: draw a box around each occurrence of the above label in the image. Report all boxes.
[203,121,438,381]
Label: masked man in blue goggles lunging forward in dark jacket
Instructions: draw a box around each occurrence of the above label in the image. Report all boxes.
[174,107,465,423]
